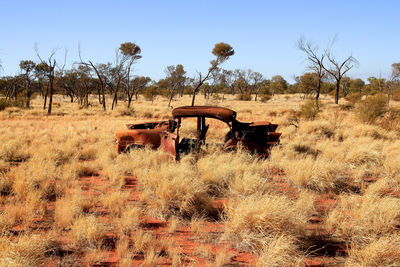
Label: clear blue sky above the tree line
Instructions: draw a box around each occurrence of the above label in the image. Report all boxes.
[0,0,400,82]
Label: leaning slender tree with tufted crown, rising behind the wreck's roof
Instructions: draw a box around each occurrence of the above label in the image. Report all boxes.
[192,42,235,106]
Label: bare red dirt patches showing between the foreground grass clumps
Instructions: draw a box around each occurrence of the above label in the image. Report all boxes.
[10,166,382,267]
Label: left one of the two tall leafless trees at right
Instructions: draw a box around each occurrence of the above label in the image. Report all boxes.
[297,38,326,102]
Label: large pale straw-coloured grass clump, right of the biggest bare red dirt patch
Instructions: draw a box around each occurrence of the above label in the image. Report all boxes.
[225,194,313,251]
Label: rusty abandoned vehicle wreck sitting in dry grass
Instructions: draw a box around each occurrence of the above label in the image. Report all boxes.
[116,106,281,159]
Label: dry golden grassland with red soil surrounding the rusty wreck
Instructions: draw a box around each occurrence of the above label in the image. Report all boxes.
[0,95,400,266]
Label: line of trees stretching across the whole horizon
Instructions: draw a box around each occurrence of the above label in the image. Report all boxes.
[0,39,400,114]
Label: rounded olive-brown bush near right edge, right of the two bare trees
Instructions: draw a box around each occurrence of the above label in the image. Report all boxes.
[358,95,387,123]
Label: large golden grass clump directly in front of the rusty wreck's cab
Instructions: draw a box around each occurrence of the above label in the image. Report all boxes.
[130,152,213,218]
